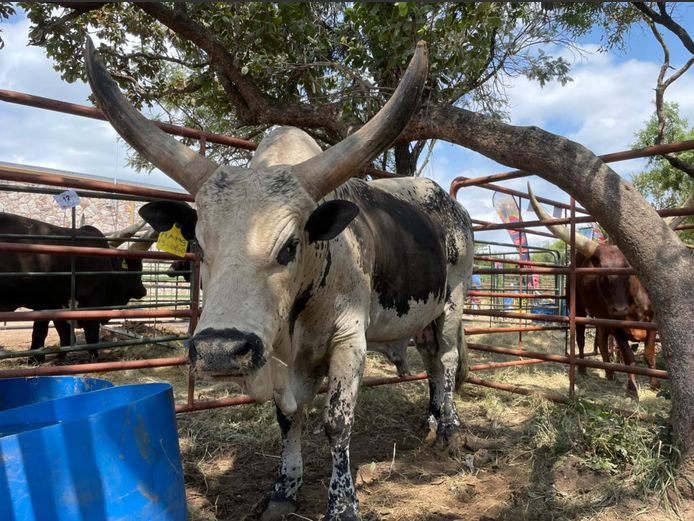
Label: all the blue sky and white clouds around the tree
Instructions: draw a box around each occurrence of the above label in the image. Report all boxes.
[0,4,694,243]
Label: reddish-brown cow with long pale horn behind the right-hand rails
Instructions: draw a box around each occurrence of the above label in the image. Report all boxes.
[528,185,658,398]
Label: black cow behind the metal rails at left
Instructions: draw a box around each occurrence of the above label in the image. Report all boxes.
[0,213,149,362]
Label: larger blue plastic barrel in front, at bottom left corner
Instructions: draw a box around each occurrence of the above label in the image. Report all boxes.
[0,383,186,521]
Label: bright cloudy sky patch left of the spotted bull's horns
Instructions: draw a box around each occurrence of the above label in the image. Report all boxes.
[0,19,182,192]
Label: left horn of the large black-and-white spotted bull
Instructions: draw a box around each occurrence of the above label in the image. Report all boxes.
[84,37,218,195]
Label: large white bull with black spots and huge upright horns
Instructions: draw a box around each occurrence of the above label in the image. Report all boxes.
[86,38,473,521]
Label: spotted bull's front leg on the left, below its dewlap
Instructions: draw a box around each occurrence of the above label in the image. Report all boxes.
[261,405,304,521]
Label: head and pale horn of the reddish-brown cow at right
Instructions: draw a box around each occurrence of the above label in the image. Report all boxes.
[528,184,650,320]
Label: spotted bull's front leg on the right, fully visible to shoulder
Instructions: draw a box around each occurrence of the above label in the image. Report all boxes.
[323,332,366,521]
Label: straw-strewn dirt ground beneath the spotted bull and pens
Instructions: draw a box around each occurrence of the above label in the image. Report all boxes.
[0,316,694,521]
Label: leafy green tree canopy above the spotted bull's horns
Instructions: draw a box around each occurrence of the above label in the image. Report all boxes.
[0,2,635,174]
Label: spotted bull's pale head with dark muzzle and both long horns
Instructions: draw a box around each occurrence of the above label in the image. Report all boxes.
[85,41,427,391]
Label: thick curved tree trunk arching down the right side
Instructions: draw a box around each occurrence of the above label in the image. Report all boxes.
[408,105,694,490]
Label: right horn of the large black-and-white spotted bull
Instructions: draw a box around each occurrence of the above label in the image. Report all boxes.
[293,42,428,201]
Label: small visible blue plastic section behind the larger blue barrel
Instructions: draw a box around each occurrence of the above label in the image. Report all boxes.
[0,376,113,411]
